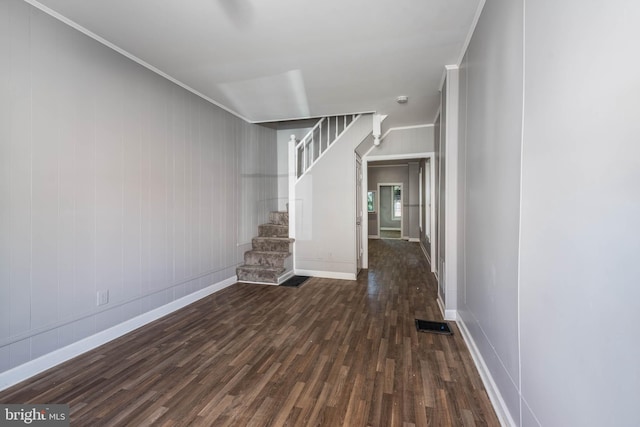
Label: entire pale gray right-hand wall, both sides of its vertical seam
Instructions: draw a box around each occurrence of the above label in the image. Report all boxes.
[458,0,640,426]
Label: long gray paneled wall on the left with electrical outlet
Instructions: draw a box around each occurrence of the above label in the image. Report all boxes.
[0,0,277,372]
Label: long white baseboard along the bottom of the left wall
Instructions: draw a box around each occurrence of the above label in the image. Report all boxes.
[0,276,237,391]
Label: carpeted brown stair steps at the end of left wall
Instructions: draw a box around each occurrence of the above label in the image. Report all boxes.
[236,212,293,285]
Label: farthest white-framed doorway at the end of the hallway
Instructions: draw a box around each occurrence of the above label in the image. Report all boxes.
[378,183,404,239]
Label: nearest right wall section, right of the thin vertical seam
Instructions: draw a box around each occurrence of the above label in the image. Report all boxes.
[519,0,640,426]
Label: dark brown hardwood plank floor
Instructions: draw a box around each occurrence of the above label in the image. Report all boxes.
[0,240,499,427]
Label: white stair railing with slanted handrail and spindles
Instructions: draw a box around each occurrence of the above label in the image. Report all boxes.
[291,114,358,179]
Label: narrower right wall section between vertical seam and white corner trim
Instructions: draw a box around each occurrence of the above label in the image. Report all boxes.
[458,0,524,420]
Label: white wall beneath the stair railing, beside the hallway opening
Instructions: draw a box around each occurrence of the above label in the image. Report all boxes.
[294,114,372,279]
